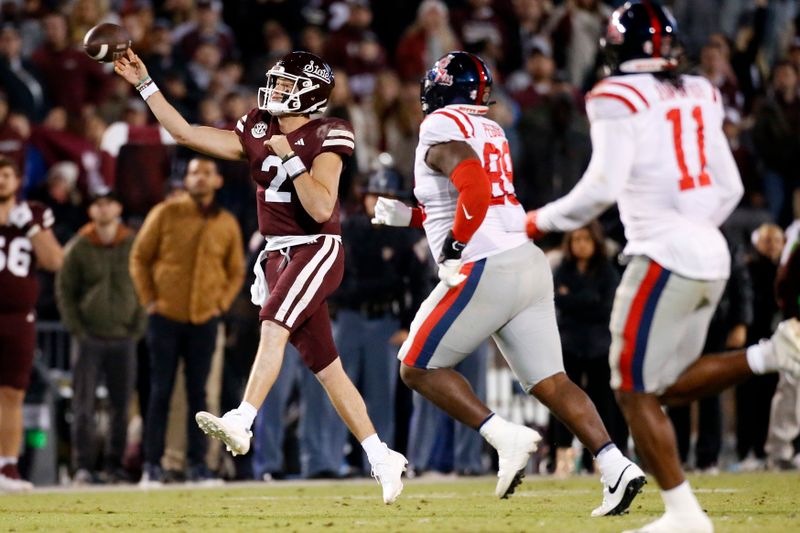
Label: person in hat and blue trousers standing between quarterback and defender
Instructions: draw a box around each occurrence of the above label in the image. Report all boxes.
[318,166,427,474]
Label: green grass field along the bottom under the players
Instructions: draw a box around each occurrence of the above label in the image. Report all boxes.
[0,473,800,533]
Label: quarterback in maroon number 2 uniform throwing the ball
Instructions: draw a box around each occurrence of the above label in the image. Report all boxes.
[114,50,406,503]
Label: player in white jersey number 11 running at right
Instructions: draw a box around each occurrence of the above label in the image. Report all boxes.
[528,0,800,533]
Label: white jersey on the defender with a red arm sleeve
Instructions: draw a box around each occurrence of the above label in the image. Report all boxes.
[414,105,528,262]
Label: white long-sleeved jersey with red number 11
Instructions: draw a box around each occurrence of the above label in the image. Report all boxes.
[536,74,743,280]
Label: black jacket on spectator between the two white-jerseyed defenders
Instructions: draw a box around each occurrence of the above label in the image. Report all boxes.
[553,260,619,358]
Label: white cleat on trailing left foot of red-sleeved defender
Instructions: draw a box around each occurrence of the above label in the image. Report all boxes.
[485,422,542,499]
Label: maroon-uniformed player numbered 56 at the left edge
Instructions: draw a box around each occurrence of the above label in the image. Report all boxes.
[0,157,64,492]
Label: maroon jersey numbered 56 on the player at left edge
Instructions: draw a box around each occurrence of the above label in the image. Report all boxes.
[0,202,55,313]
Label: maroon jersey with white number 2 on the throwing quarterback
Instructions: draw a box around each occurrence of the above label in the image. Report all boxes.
[233,108,354,236]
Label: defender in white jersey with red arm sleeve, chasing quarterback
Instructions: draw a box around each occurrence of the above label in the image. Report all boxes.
[373,52,645,516]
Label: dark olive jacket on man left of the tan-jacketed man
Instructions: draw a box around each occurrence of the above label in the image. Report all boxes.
[56,223,147,339]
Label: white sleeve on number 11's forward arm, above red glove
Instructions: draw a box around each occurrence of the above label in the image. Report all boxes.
[536,118,636,232]
